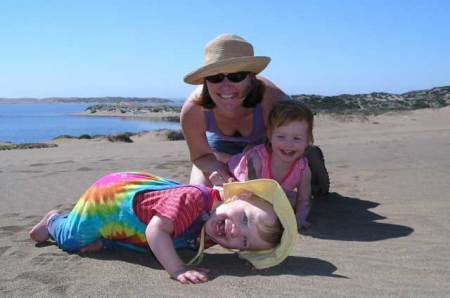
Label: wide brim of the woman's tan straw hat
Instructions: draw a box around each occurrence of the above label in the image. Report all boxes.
[184,56,270,85]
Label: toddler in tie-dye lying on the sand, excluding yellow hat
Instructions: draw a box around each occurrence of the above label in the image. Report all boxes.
[30,172,295,283]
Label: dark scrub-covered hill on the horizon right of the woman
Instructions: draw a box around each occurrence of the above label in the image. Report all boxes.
[292,86,450,115]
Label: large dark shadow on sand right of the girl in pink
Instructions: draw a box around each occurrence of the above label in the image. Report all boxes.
[301,193,414,241]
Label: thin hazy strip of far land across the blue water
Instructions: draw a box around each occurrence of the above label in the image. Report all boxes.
[0,96,177,105]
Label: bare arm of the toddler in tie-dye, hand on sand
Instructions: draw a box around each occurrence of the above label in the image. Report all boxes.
[145,215,208,283]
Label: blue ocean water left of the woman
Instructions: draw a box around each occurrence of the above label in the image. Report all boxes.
[0,103,180,143]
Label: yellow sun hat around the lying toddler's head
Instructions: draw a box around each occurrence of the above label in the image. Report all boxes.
[223,179,297,269]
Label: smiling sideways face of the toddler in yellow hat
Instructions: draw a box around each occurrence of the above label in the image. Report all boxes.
[205,195,276,250]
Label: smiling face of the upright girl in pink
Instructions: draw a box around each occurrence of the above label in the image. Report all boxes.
[268,120,309,162]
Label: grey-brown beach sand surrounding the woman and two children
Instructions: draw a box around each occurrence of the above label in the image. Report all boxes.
[0,108,450,297]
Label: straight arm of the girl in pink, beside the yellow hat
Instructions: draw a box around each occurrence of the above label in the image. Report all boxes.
[295,165,311,230]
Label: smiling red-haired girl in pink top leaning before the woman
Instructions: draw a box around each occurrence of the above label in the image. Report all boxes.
[210,100,314,230]
